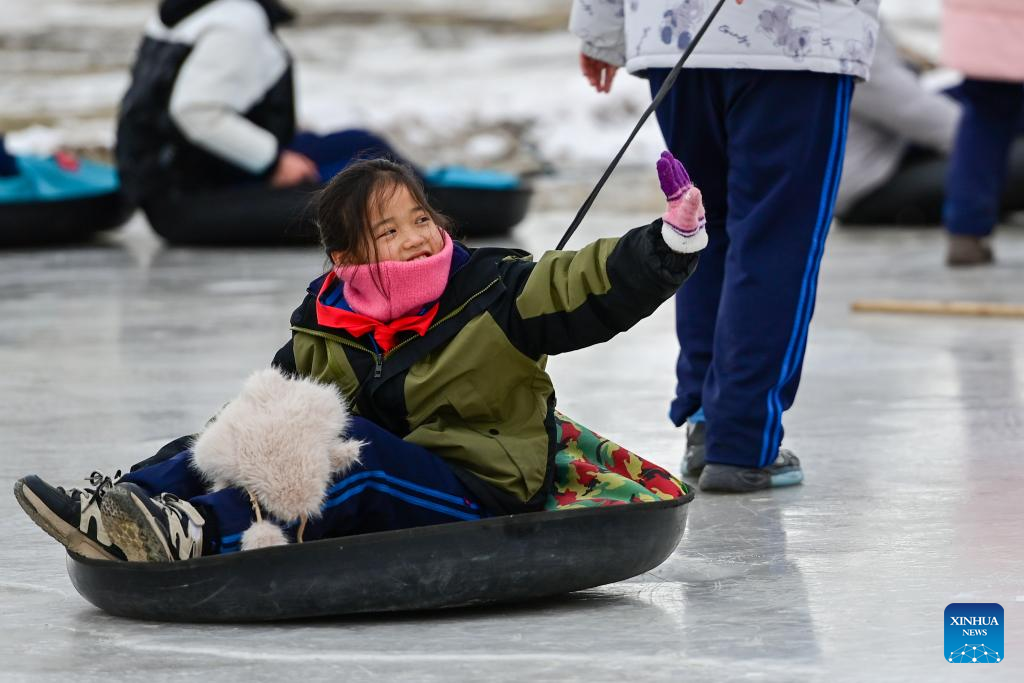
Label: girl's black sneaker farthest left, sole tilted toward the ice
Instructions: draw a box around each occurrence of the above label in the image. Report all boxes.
[14,472,125,560]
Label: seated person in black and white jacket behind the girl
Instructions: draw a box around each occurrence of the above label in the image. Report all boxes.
[116,0,396,208]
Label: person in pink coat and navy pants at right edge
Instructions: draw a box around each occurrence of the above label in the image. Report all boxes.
[942,0,1024,266]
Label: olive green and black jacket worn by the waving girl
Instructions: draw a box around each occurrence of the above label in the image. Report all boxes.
[274,220,697,512]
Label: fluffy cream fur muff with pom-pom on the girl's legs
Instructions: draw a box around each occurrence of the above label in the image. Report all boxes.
[193,369,362,550]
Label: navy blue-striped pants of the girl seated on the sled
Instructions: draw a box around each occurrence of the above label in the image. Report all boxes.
[121,417,488,553]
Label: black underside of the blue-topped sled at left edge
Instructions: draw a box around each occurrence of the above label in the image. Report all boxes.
[0,191,133,248]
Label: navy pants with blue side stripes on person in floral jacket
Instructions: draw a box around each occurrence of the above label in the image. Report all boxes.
[646,69,853,467]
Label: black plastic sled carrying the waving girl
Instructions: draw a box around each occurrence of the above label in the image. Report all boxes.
[68,493,693,623]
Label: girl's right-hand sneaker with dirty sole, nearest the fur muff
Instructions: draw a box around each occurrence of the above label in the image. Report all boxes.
[99,483,205,562]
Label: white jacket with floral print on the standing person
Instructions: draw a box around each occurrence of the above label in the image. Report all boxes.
[569,0,879,79]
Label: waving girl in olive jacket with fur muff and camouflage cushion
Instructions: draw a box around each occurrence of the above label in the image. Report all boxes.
[14,153,708,561]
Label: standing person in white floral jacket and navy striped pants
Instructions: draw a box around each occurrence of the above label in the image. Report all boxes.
[569,0,879,493]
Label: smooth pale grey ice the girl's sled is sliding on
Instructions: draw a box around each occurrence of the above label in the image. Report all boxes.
[0,196,1024,682]
